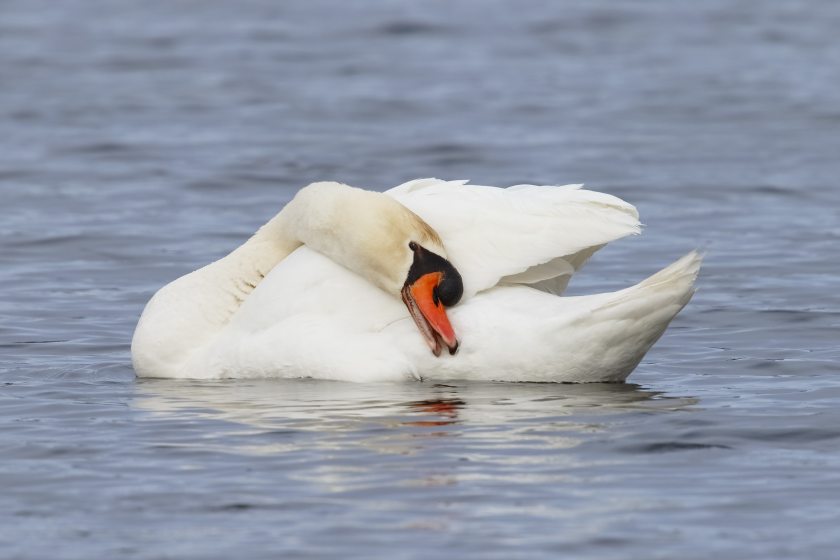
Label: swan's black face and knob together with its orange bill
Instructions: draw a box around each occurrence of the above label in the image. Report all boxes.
[400,241,464,356]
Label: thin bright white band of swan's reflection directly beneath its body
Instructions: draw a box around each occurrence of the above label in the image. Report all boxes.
[133,379,696,432]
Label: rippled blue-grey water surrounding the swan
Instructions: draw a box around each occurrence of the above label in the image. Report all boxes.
[0,0,840,559]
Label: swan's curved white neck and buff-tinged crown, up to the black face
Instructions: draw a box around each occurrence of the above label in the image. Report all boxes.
[131,183,445,377]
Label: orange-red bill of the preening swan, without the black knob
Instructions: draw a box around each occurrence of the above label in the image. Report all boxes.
[402,272,458,356]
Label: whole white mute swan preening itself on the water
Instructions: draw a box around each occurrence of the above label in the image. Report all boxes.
[132,179,701,382]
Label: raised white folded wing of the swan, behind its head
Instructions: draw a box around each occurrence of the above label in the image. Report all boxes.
[386,179,640,297]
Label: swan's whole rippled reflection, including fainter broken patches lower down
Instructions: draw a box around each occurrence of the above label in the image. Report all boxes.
[131,379,696,491]
